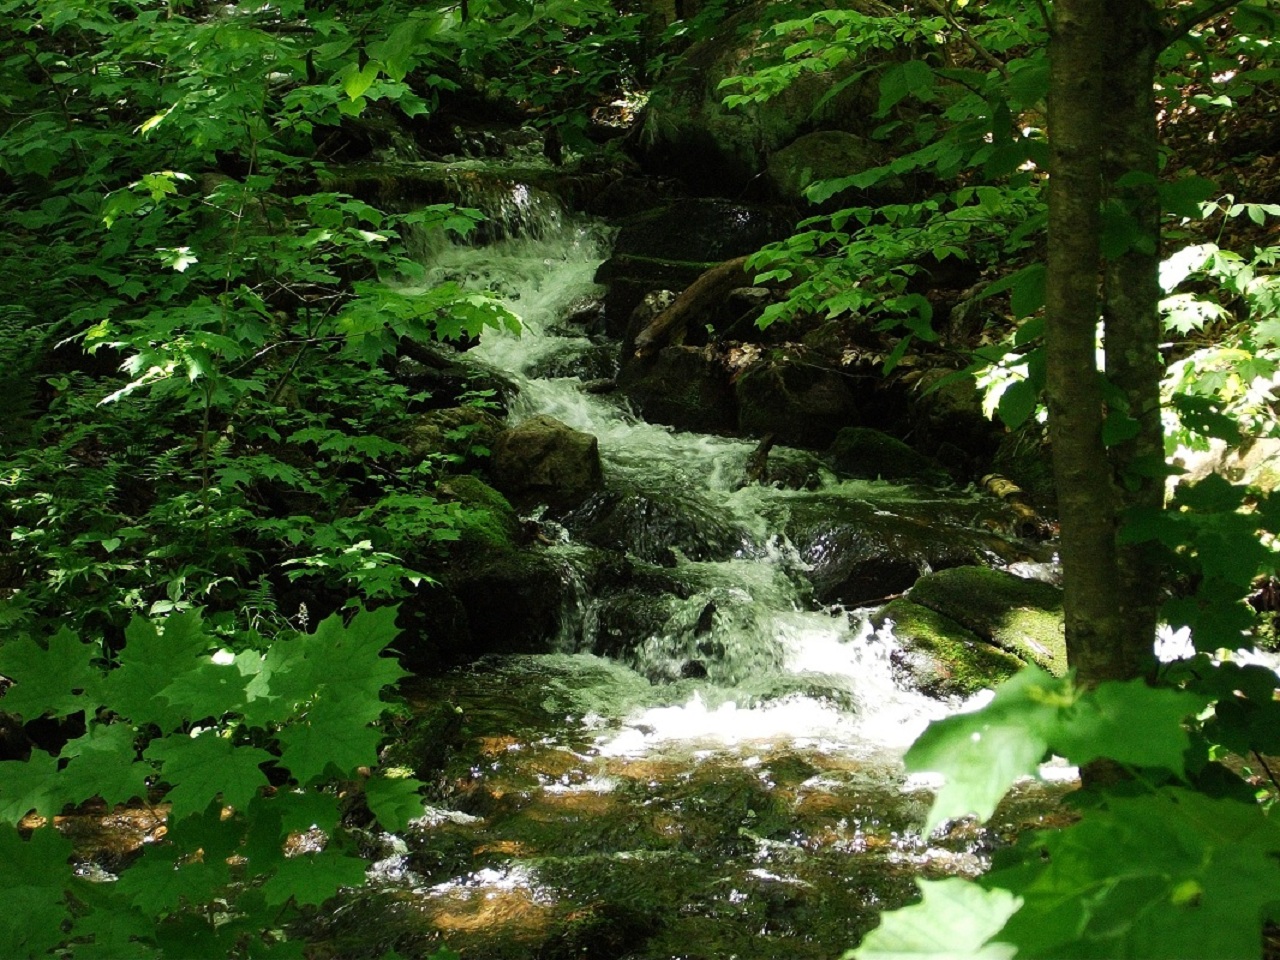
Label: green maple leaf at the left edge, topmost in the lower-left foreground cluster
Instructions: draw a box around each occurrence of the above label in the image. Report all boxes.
[0,627,101,719]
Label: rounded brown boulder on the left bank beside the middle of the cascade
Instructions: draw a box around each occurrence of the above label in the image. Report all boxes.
[493,413,604,509]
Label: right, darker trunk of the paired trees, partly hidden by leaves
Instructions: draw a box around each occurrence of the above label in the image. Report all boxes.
[1092,0,1165,680]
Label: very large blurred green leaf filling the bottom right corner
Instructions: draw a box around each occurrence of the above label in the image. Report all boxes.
[983,787,1280,960]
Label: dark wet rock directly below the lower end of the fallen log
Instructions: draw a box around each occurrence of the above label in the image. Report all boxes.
[618,347,737,433]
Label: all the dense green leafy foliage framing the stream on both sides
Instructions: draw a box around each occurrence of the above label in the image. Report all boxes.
[0,0,1280,957]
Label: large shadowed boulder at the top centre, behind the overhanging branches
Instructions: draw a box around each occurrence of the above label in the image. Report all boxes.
[631,0,878,195]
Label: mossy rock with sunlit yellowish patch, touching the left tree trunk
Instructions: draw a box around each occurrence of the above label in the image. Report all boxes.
[910,567,1066,676]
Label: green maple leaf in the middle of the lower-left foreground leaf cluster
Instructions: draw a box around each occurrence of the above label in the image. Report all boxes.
[145,732,275,818]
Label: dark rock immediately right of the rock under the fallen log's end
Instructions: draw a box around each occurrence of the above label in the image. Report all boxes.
[735,353,858,448]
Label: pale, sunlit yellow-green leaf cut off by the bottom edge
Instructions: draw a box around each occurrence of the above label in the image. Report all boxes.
[844,877,1023,960]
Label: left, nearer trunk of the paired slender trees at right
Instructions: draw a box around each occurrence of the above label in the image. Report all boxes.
[1044,0,1123,685]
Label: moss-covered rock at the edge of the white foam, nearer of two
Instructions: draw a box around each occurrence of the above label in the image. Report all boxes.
[873,600,1025,698]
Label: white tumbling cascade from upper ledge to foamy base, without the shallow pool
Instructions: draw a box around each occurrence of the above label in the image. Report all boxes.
[409,186,977,749]
